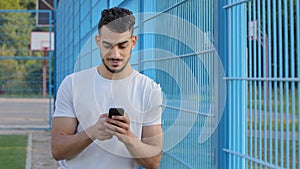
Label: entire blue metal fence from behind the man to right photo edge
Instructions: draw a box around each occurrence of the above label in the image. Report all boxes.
[55,0,300,169]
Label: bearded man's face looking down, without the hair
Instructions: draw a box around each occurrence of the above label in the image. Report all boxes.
[96,26,136,73]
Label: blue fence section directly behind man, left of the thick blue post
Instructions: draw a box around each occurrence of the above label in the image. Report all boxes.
[56,0,225,168]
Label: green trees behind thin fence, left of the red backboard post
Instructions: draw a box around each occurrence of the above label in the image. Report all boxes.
[0,0,50,95]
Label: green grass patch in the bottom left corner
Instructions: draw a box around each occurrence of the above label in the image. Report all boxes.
[0,135,28,169]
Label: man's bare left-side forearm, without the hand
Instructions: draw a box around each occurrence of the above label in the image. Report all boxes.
[51,131,93,160]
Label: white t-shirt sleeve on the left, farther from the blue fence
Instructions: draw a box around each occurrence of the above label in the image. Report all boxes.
[53,75,75,117]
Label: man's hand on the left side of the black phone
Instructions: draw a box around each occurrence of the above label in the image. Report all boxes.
[86,114,113,140]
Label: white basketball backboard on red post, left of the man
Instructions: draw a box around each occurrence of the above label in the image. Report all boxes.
[30,32,54,51]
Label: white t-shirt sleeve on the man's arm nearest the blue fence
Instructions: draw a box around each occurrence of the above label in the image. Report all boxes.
[143,85,162,126]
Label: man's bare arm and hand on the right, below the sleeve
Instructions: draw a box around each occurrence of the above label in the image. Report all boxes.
[104,113,162,168]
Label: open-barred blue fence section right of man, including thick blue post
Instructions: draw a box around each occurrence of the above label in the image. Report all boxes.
[226,0,300,169]
